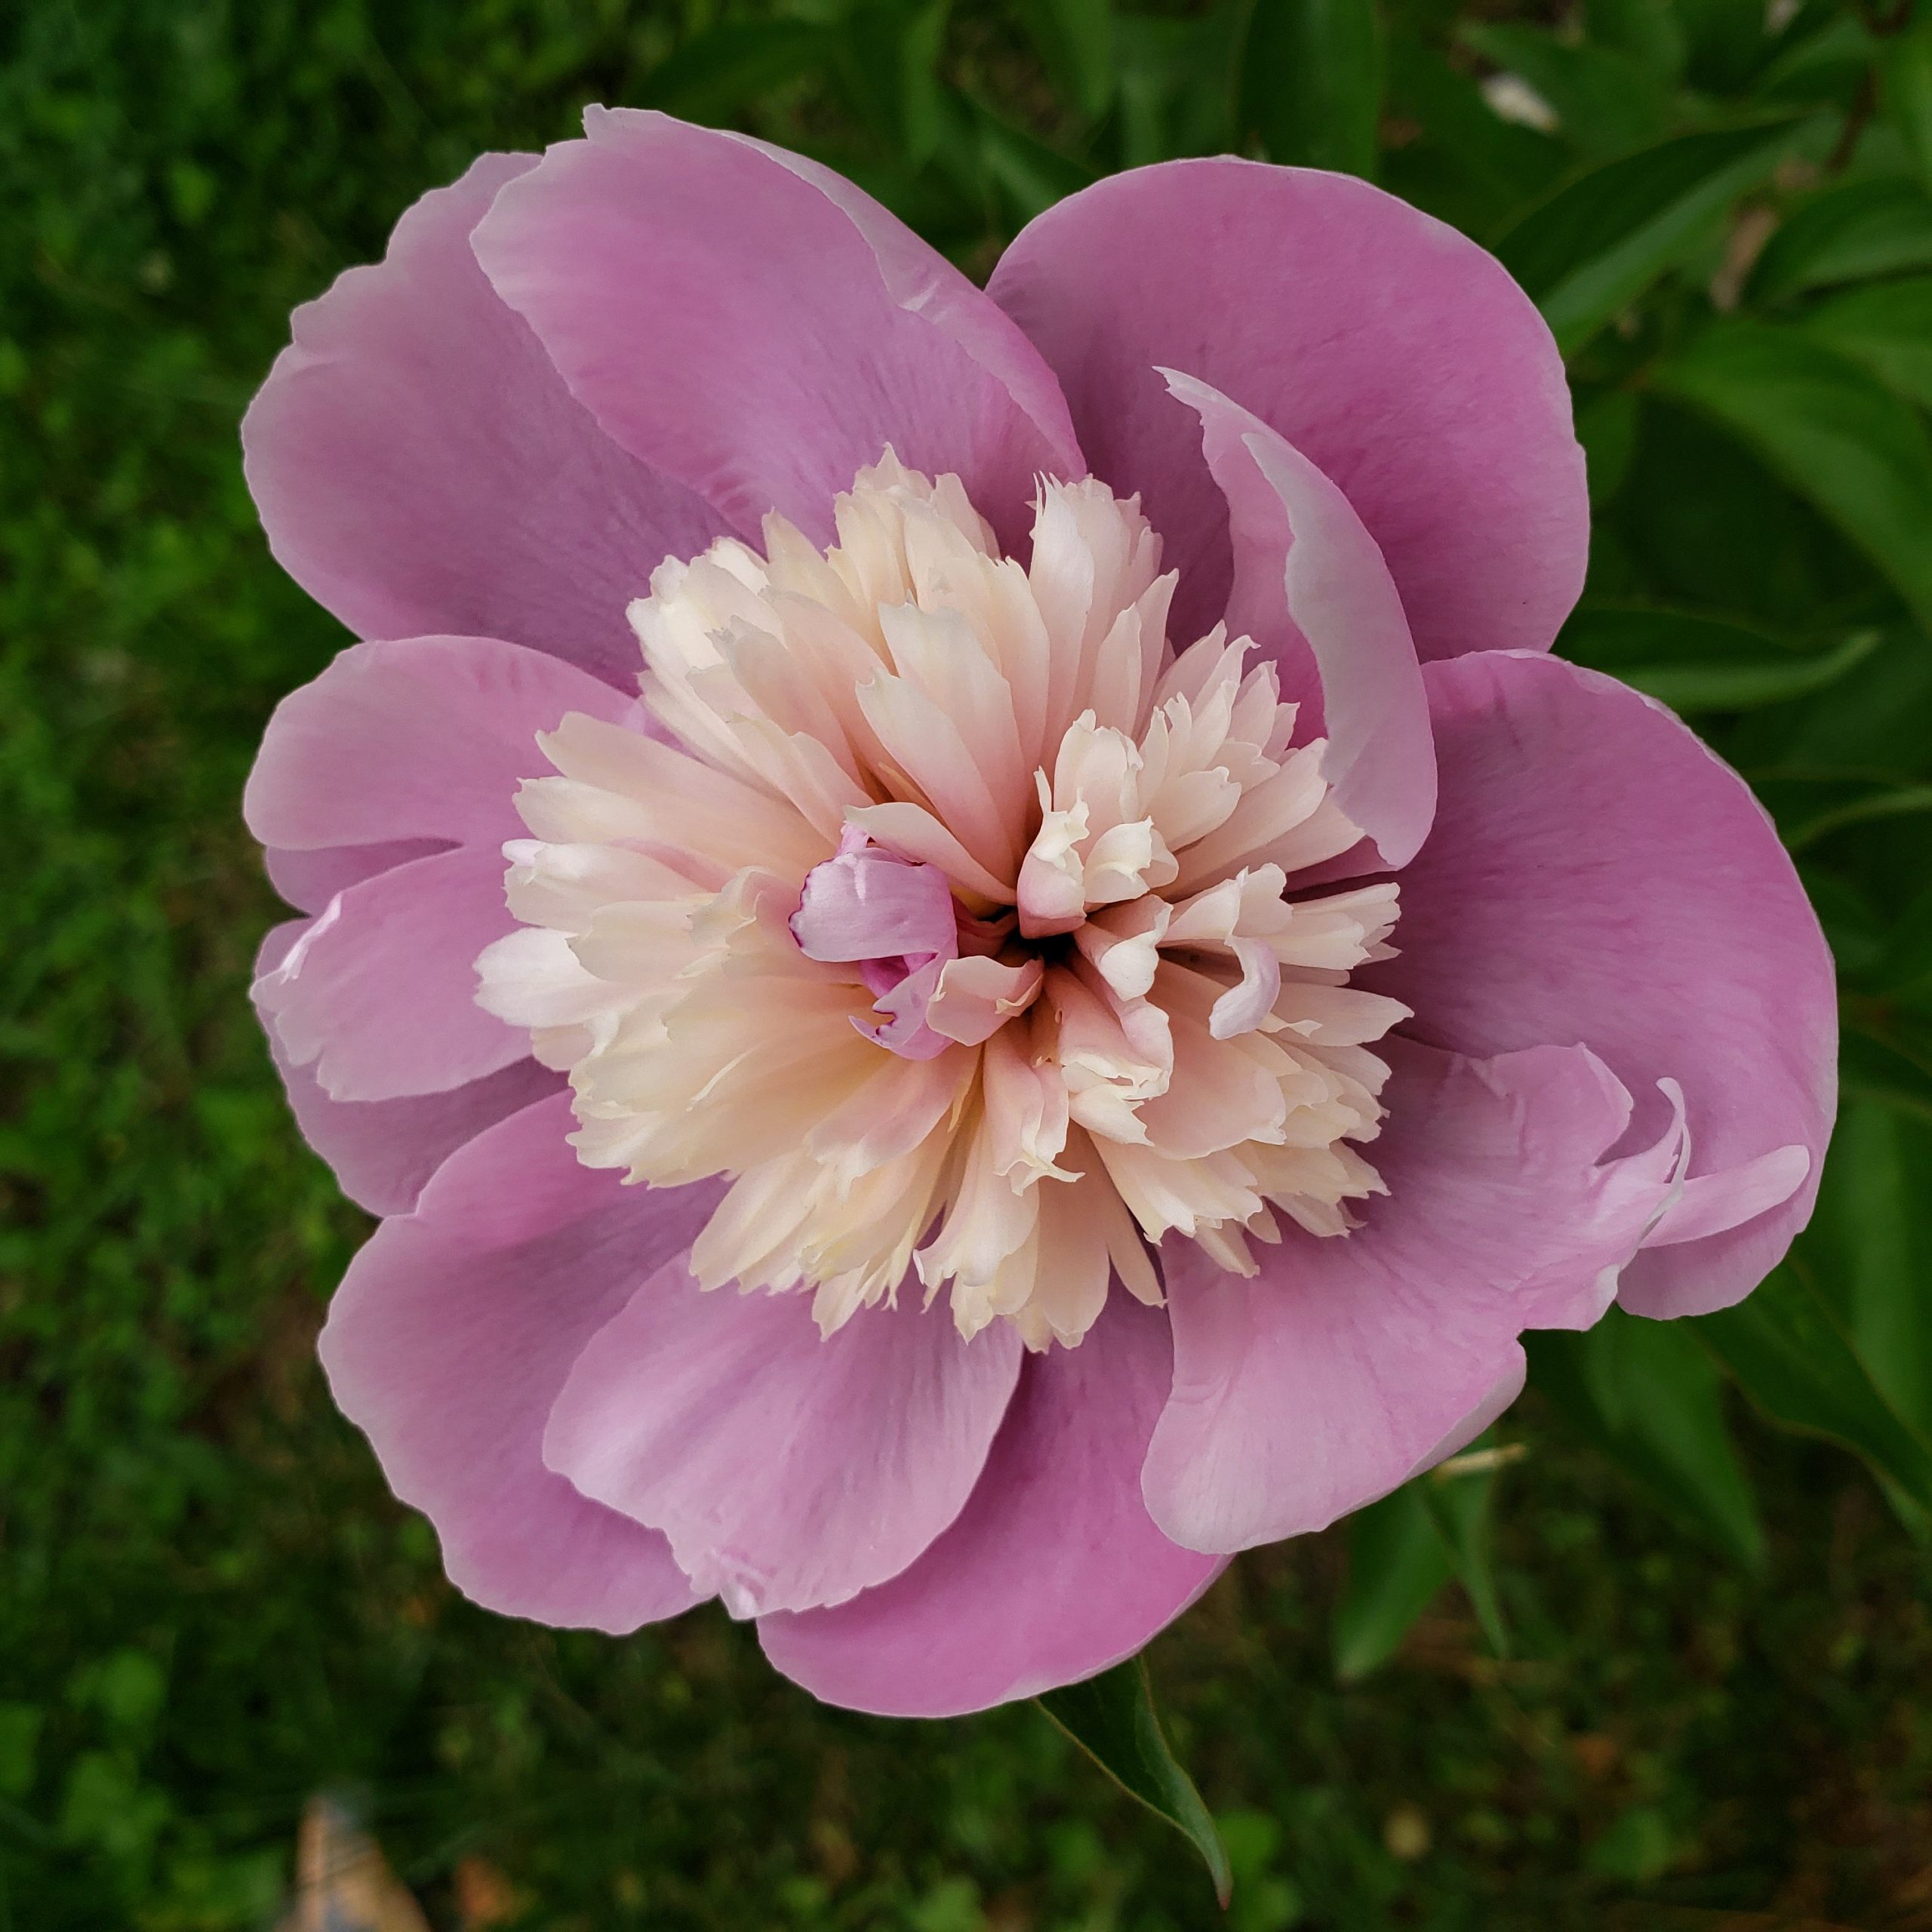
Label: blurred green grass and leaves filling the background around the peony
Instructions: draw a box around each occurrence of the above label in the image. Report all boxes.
[0,0,1932,1932]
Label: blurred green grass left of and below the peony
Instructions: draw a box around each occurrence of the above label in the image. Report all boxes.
[0,0,1932,1932]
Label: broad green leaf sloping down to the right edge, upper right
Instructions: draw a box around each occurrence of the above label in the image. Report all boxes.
[1650,317,1932,624]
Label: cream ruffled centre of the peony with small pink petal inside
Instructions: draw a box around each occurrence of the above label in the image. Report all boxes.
[479,452,1404,1349]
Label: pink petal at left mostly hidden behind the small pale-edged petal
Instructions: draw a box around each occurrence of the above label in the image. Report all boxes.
[255,920,562,1214]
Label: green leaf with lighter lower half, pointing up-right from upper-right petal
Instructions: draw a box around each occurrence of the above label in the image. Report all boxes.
[1497,120,1804,353]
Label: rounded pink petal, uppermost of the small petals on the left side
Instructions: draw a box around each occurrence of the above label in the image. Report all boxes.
[242,638,635,848]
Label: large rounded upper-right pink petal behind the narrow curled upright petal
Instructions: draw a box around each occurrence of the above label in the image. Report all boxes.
[989,158,1588,659]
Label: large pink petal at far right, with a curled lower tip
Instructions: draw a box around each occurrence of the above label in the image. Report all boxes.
[1364,655,1838,1315]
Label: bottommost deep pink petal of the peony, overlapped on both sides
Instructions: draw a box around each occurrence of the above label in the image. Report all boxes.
[759,1287,1221,1718]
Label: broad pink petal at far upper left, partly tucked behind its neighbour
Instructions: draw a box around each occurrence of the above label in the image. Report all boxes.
[242,155,721,682]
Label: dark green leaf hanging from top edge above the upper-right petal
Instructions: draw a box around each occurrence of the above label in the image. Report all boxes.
[1235,0,1383,180]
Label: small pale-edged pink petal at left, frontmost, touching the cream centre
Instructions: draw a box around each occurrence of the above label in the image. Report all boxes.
[253,846,529,1100]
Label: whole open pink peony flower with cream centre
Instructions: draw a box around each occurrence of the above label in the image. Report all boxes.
[245,110,1833,1715]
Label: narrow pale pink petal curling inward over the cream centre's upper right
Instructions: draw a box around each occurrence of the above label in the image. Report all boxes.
[1163,371,1435,867]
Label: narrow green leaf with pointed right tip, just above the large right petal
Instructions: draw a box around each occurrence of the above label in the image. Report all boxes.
[1559,605,1881,713]
